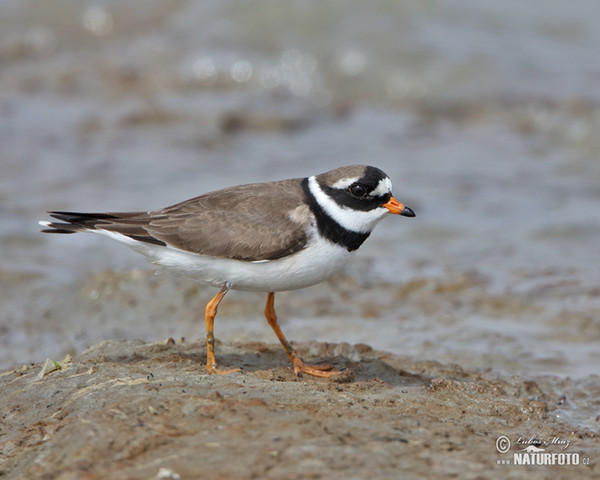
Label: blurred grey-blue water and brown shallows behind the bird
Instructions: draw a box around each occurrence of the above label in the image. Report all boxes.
[0,0,600,416]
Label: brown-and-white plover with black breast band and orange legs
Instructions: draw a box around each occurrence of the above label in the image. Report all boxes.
[39,165,415,377]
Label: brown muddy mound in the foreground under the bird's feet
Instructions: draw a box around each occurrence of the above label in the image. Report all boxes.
[0,340,600,480]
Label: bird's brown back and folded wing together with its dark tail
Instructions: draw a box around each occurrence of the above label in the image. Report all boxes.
[45,180,308,261]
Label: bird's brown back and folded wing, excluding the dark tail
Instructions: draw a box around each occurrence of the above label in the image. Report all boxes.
[146,180,307,261]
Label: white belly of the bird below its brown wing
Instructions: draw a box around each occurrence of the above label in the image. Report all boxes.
[99,231,352,292]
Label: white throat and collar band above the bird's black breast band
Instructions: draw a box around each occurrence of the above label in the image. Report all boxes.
[308,175,389,233]
